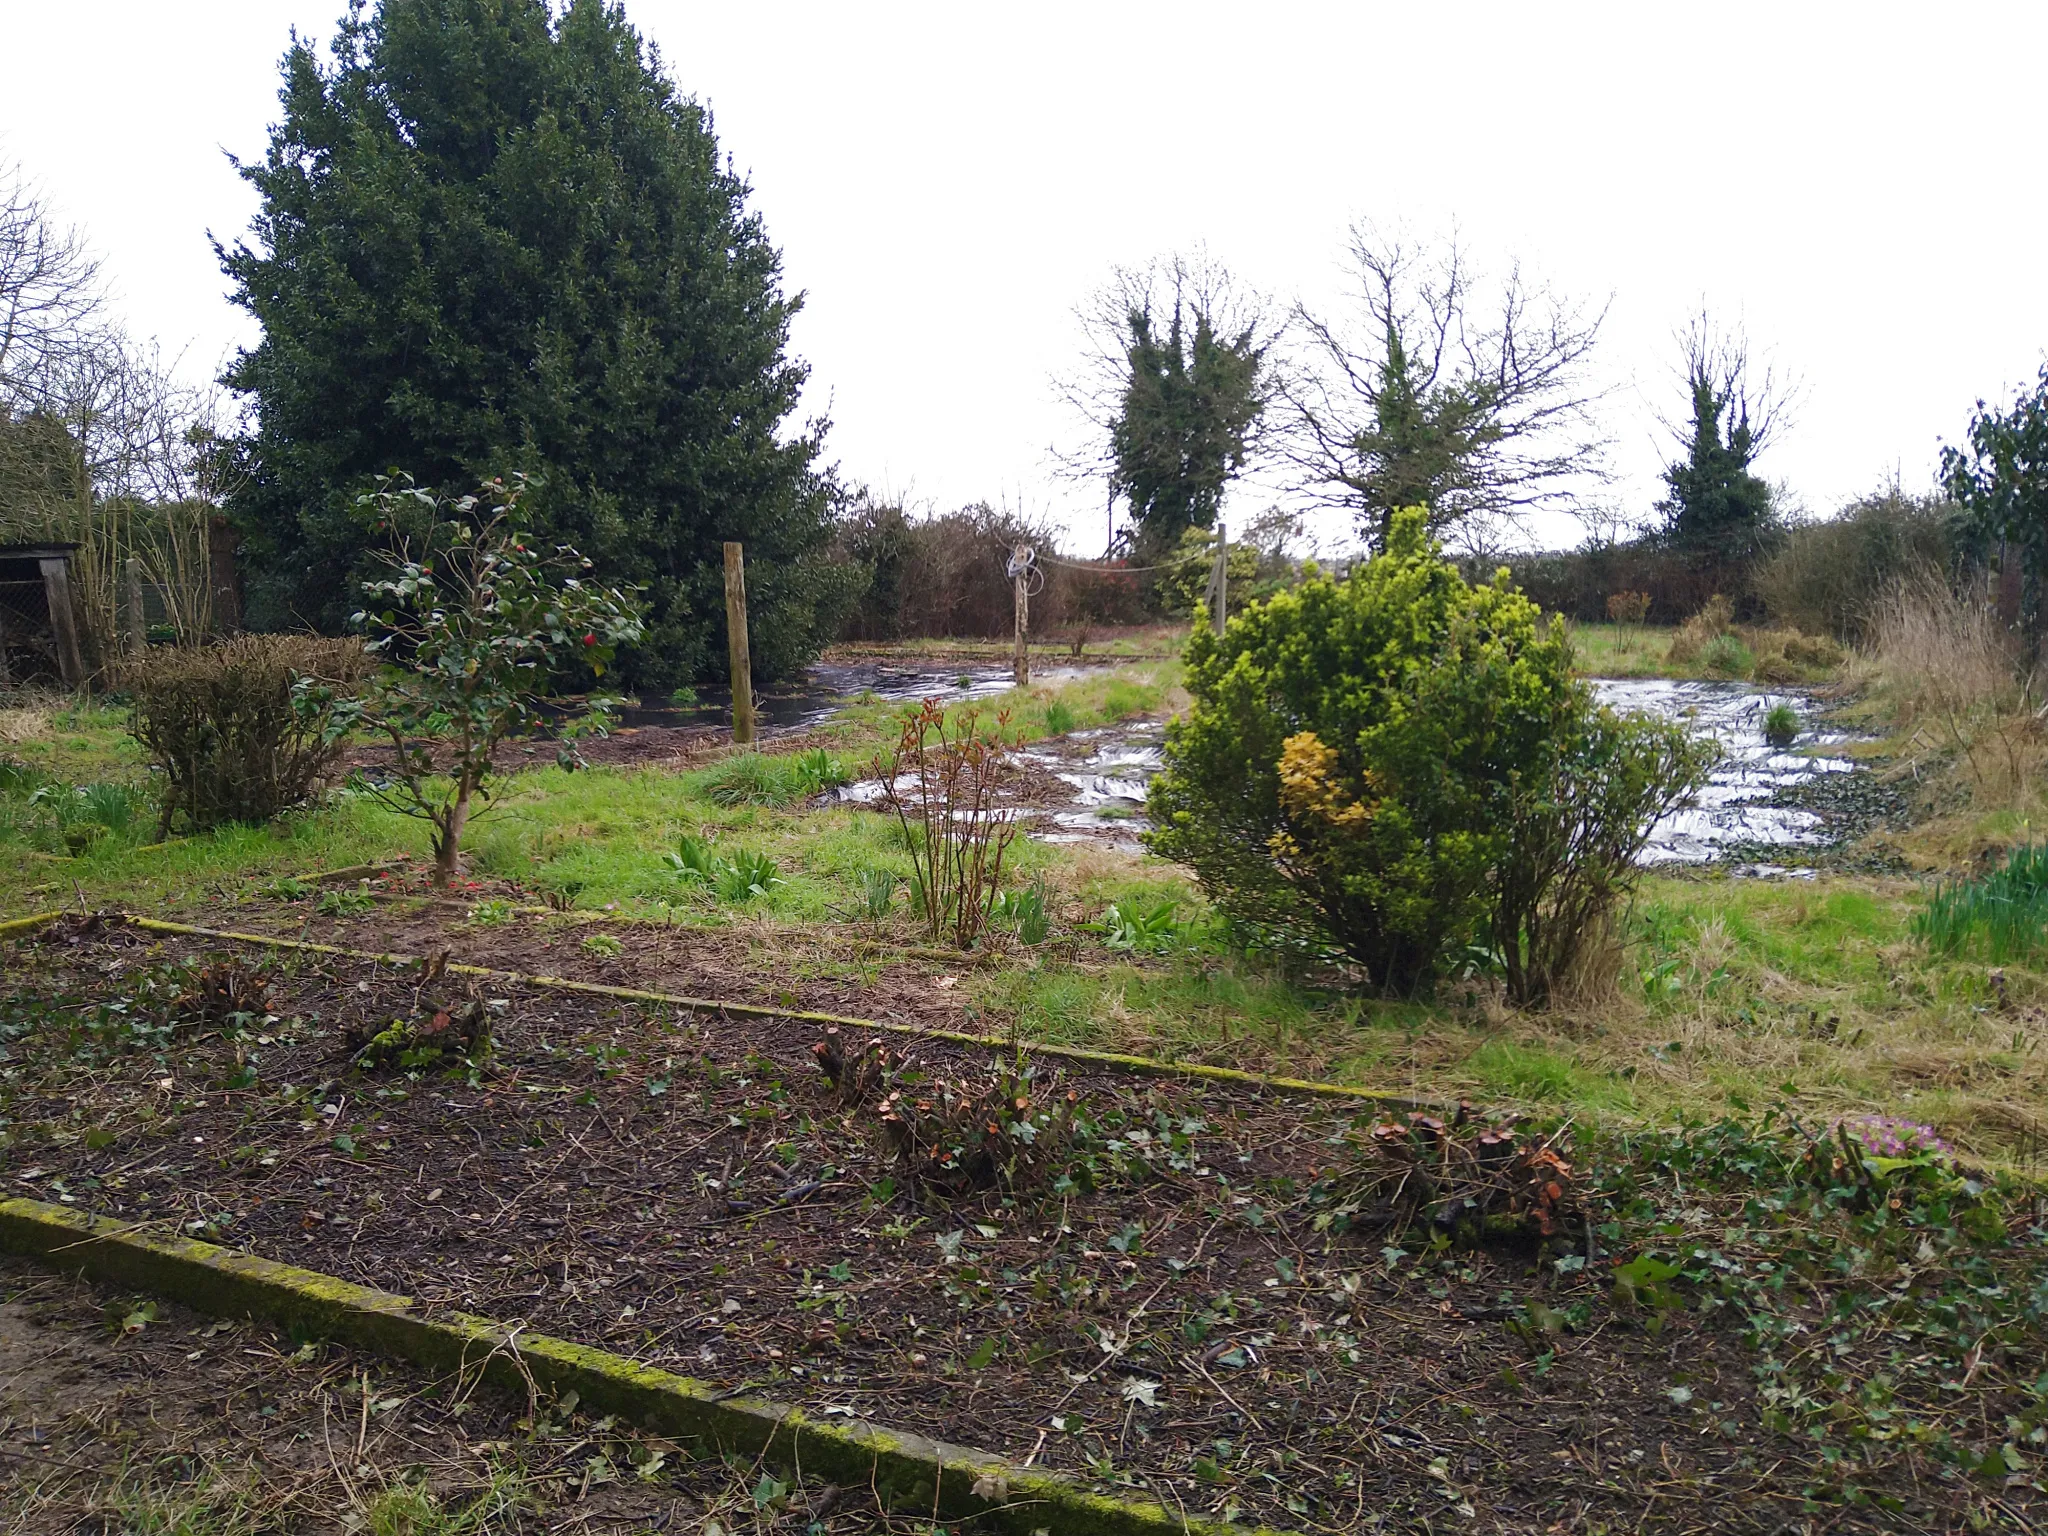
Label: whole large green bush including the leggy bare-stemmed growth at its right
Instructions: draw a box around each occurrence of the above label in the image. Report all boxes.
[1149,510,1700,1001]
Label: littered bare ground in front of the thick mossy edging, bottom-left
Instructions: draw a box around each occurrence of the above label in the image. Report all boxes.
[0,1260,909,1536]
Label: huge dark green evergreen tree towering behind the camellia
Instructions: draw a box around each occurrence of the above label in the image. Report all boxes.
[221,0,848,684]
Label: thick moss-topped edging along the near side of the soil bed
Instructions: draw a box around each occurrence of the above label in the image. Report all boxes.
[0,1200,1280,1536]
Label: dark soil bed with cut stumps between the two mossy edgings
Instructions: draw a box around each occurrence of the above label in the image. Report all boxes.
[0,920,2040,1532]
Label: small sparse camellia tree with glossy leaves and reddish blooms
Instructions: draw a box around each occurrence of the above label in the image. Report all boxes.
[325,475,643,889]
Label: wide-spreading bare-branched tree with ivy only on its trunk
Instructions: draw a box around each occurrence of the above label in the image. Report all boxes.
[1282,223,1608,547]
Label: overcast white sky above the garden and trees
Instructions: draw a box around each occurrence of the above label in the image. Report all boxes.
[0,0,2048,543]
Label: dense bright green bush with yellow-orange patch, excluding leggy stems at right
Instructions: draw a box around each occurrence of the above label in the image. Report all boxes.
[1151,508,1573,989]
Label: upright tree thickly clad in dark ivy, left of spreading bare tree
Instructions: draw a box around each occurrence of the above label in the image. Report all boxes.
[1110,293,1268,557]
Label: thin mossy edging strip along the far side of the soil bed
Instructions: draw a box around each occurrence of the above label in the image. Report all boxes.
[116,913,1421,1110]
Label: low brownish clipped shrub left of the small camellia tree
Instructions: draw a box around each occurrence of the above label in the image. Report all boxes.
[119,635,369,838]
